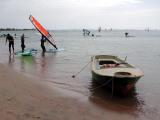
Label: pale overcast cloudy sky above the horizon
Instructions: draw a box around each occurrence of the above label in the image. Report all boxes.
[0,0,160,29]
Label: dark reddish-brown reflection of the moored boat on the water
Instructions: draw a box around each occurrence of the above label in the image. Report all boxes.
[89,81,145,116]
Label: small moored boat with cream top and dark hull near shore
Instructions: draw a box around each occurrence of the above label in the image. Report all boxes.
[91,55,144,95]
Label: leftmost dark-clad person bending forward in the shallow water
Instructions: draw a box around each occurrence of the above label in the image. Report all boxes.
[5,34,14,54]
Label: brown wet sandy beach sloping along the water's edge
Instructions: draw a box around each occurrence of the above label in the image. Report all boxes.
[0,64,142,120]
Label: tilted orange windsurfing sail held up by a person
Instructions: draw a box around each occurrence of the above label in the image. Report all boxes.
[29,15,57,49]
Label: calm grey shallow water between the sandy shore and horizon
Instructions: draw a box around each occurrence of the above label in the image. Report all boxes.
[0,30,160,120]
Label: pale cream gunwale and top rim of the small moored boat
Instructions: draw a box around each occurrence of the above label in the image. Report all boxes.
[91,55,143,78]
